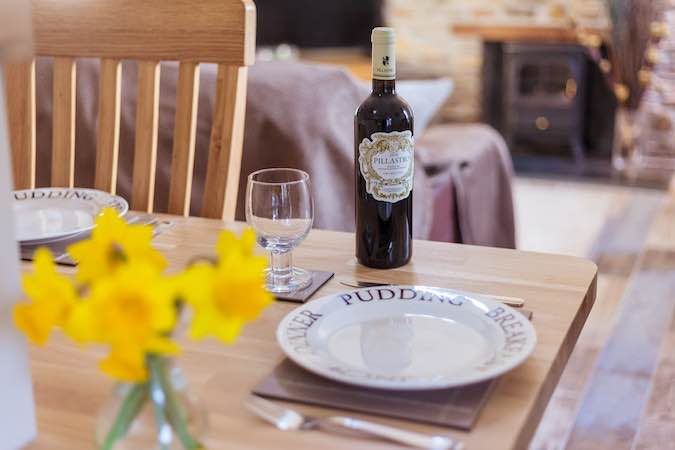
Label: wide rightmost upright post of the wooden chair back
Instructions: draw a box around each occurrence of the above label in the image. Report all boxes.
[206,64,248,220]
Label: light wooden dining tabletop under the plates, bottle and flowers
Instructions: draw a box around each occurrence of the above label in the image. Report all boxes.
[24,216,597,450]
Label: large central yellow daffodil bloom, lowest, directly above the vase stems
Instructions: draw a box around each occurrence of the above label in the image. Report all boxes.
[65,263,178,381]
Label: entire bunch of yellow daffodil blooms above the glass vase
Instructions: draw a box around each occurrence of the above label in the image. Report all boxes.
[14,220,272,382]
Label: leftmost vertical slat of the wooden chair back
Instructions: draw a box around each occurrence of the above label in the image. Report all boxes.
[4,61,35,189]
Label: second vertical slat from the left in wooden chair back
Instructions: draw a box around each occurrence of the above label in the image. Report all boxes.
[51,57,75,187]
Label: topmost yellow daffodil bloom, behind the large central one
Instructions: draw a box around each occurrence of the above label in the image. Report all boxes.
[68,208,166,283]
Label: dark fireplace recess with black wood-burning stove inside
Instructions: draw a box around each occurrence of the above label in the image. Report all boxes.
[482,42,616,177]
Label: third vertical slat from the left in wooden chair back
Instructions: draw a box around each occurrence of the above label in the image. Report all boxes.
[94,58,122,193]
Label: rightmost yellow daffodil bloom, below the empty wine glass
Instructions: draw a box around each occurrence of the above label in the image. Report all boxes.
[181,230,272,343]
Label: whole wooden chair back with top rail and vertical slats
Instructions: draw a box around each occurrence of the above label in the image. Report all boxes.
[5,0,255,220]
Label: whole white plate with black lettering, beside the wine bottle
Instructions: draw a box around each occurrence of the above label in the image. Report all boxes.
[277,286,537,390]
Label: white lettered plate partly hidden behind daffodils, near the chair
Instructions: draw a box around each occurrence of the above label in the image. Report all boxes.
[14,188,129,244]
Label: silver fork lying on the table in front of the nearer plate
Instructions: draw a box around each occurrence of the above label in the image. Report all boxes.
[244,395,464,450]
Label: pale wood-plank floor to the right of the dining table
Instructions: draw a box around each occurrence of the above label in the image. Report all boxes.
[515,178,675,450]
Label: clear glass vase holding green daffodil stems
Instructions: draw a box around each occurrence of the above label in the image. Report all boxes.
[96,356,208,450]
